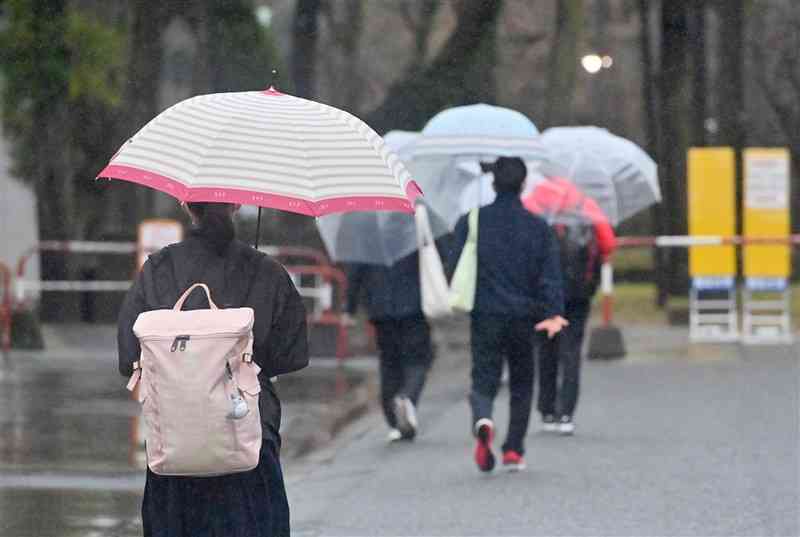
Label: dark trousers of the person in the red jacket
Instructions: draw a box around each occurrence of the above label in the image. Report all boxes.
[537,300,591,416]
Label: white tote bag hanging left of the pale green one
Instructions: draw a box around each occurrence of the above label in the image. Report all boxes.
[415,204,452,319]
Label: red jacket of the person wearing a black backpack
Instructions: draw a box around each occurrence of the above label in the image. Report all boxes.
[522,177,617,260]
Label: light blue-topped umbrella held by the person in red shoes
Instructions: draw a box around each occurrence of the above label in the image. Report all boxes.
[398,104,547,229]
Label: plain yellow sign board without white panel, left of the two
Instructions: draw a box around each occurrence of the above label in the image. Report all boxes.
[688,147,736,278]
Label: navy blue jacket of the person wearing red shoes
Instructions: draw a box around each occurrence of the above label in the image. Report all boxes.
[448,193,564,322]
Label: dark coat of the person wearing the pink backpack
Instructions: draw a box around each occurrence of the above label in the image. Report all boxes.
[117,233,308,447]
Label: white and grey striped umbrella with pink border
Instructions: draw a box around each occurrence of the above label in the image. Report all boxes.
[98,88,421,216]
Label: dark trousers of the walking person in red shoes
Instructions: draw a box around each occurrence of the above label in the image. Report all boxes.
[469,314,535,454]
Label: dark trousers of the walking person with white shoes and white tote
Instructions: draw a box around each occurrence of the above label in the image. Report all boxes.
[373,316,433,427]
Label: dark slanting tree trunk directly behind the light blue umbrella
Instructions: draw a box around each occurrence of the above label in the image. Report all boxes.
[366,0,503,132]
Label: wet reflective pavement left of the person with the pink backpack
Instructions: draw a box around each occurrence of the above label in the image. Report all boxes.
[0,353,143,537]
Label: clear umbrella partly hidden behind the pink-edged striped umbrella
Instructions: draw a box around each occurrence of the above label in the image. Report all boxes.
[317,131,448,266]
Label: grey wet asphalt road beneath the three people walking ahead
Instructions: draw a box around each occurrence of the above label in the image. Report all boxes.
[289,330,800,537]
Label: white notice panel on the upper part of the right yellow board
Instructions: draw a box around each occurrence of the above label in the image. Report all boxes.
[744,151,789,211]
